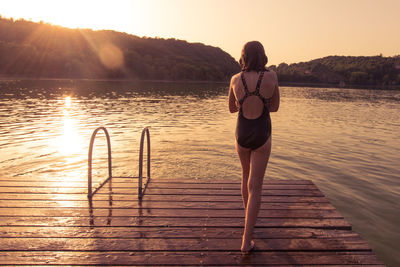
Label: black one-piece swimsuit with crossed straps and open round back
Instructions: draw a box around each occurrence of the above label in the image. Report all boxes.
[236,72,271,150]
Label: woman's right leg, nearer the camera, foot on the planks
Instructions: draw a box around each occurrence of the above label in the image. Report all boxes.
[241,137,271,251]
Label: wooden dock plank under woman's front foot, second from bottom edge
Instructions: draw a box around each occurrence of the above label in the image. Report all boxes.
[0,237,371,252]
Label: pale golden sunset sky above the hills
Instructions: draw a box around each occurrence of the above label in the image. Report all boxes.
[0,0,400,65]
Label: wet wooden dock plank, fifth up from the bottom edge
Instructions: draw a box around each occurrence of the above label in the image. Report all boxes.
[0,208,343,219]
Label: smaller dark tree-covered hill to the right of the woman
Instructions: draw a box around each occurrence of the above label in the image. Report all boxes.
[270,56,400,86]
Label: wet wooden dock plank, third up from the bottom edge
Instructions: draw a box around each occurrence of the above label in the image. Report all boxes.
[0,226,358,240]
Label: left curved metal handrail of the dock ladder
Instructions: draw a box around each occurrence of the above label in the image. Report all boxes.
[88,127,112,198]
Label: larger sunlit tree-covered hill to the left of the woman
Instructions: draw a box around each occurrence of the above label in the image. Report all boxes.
[0,17,240,81]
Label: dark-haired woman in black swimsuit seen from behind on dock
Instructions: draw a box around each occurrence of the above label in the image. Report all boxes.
[229,41,279,253]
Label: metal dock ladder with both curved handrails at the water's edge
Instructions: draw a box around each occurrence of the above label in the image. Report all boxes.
[88,127,150,199]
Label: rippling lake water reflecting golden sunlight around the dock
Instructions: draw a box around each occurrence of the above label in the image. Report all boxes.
[0,81,400,266]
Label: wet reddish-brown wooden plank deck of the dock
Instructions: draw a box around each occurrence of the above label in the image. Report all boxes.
[0,178,383,266]
